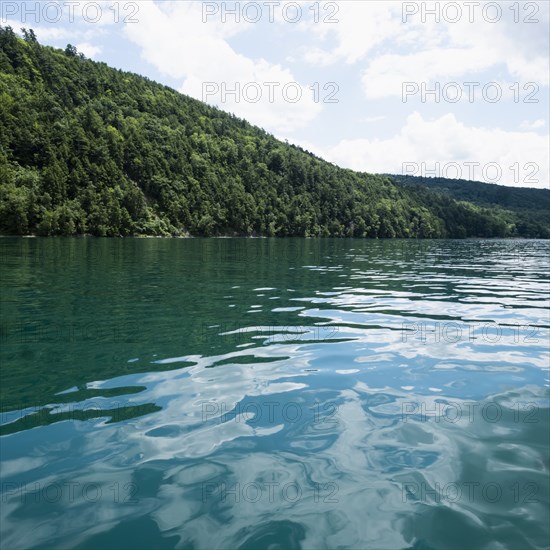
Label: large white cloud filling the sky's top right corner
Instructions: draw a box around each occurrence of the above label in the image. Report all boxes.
[303,2,549,98]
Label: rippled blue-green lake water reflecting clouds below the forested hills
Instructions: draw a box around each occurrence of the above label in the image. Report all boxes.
[0,238,550,550]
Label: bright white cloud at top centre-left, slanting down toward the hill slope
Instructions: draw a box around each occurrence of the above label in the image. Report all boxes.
[125,1,322,132]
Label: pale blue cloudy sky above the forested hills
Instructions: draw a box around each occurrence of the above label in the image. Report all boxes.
[0,0,550,188]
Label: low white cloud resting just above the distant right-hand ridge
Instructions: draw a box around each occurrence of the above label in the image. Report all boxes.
[315,112,550,188]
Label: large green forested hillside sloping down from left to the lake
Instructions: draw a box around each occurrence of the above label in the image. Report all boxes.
[0,27,550,238]
